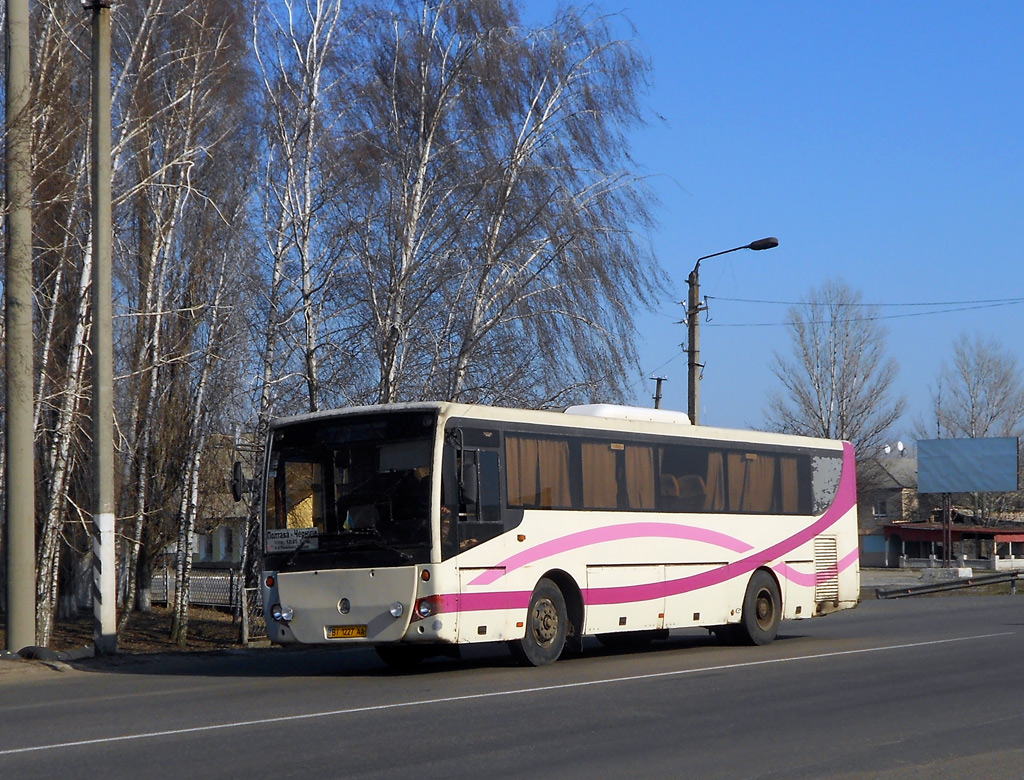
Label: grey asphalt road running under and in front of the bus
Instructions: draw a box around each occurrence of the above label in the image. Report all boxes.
[0,596,1024,780]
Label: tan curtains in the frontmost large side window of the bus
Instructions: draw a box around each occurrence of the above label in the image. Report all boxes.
[505,436,571,508]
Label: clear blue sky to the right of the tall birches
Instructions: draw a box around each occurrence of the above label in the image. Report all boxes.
[526,0,1024,441]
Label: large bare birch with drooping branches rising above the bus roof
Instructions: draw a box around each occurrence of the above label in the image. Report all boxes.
[346,0,660,403]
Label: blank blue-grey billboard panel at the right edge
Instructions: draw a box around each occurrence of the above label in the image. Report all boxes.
[918,438,1020,493]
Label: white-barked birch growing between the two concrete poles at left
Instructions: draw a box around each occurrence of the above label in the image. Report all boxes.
[22,2,91,645]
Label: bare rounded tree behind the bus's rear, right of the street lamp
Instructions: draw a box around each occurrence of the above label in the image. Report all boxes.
[766,279,905,457]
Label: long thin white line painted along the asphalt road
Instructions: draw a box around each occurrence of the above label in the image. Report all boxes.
[0,632,1016,756]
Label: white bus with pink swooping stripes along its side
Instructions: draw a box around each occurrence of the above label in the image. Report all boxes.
[262,402,859,665]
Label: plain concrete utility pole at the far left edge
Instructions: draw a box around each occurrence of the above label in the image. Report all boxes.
[4,0,36,652]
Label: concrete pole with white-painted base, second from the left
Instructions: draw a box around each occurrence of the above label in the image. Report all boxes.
[90,0,118,654]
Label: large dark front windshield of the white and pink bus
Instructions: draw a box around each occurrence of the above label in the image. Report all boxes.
[264,411,436,571]
